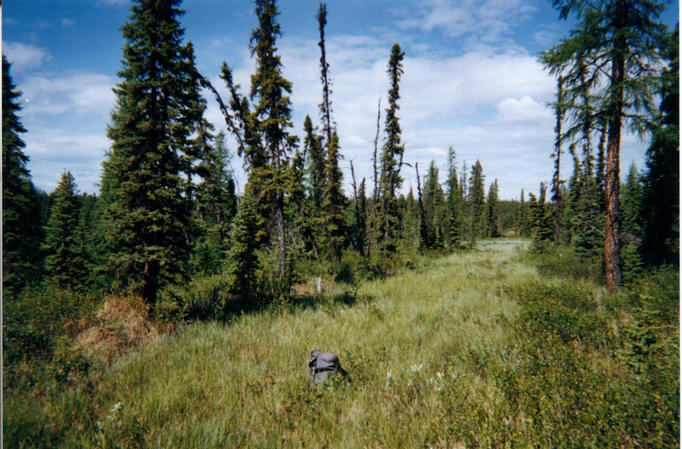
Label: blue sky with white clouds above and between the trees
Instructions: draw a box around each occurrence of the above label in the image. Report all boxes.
[0,0,679,199]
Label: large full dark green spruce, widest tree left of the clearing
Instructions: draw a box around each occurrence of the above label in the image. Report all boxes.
[102,0,205,303]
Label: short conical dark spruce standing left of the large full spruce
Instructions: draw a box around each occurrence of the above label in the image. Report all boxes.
[43,171,87,289]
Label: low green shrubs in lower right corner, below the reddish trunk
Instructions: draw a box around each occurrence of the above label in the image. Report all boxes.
[494,270,679,448]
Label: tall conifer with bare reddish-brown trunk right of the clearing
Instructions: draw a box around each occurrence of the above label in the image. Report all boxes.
[542,0,665,290]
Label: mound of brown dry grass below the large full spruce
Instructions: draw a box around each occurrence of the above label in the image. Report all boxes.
[78,297,161,361]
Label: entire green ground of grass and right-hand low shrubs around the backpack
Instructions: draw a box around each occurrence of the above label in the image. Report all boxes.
[4,239,679,448]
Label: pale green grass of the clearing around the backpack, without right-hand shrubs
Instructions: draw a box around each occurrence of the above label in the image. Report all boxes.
[5,236,679,448]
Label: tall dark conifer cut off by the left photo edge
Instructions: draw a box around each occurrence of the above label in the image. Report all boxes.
[2,54,43,292]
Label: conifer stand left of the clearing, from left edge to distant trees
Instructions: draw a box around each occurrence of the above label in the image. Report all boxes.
[3,0,527,316]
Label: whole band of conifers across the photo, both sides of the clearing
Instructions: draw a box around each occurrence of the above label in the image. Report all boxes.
[3,0,679,322]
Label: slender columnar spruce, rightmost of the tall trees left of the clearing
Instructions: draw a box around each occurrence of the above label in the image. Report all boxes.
[377,44,405,255]
